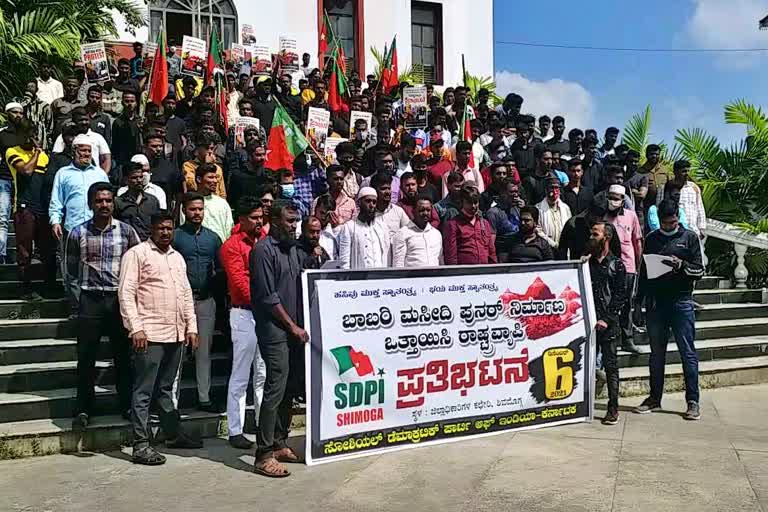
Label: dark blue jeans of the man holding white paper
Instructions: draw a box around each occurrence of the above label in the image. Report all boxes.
[647,296,699,403]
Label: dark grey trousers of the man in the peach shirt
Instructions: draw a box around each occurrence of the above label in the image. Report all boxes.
[131,342,184,450]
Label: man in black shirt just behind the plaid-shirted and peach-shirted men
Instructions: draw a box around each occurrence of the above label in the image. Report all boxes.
[114,163,161,242]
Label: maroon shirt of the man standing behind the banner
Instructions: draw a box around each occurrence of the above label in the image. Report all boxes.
[443,212,498,265]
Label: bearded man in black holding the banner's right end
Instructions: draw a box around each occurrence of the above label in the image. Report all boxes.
[582,221,629,425]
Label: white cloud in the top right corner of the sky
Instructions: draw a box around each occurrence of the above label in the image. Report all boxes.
[686,0,768,67]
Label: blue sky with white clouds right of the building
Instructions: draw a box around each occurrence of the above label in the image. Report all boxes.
[494,0,768,143]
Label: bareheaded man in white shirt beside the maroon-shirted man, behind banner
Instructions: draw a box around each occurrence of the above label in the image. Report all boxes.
[392,196,443,268]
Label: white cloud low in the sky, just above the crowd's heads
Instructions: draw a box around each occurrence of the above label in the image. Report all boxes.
[496,71,595,128]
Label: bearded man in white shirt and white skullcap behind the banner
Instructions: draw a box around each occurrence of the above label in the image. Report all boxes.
[338,187,391,270]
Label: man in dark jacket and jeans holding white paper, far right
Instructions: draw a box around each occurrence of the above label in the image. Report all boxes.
[635,200,704,420]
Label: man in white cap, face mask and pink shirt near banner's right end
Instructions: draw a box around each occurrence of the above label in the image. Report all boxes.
[605,185,643,354]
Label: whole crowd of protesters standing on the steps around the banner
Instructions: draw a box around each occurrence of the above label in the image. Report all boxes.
[0,44,706,476]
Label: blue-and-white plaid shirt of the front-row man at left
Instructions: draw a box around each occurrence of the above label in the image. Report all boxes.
[65,219,140,292]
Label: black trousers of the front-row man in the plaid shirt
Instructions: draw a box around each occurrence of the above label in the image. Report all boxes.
[75,290,131,414]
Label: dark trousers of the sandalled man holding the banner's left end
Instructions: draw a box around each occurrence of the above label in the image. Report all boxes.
[256,340,293,462]
